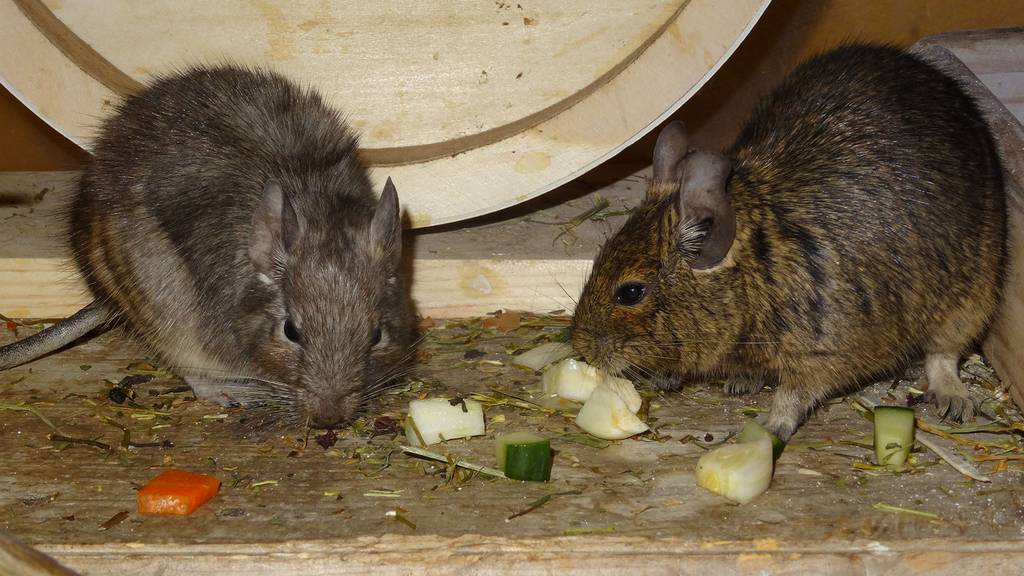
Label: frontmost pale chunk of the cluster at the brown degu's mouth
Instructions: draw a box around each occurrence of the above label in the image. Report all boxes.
[575,378,647,440]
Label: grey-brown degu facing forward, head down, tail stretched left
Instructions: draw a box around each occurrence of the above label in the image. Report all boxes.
[0,66,413,427]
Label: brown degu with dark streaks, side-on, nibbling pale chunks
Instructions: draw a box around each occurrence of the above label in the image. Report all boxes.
[572,44,1006,441]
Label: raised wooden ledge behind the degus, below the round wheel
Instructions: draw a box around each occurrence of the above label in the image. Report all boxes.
[0,166,646,318]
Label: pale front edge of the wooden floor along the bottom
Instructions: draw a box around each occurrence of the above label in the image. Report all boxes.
[28,535,1024,576]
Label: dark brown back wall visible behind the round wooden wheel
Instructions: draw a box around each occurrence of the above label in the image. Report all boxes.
[0,0,1024,170]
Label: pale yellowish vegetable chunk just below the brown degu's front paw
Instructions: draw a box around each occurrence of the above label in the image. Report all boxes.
[696,426,774,498]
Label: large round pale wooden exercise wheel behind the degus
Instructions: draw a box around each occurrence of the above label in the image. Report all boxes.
[0,0,767,228]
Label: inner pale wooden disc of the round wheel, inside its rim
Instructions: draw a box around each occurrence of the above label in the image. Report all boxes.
[14,0,687,154]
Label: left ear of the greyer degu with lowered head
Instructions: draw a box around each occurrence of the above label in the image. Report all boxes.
[249,180,301,276]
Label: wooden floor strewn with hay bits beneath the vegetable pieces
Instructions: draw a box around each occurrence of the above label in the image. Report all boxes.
[0,318,1024,574]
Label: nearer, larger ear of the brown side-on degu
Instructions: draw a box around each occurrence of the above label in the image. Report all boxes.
[677,152,736,270]
